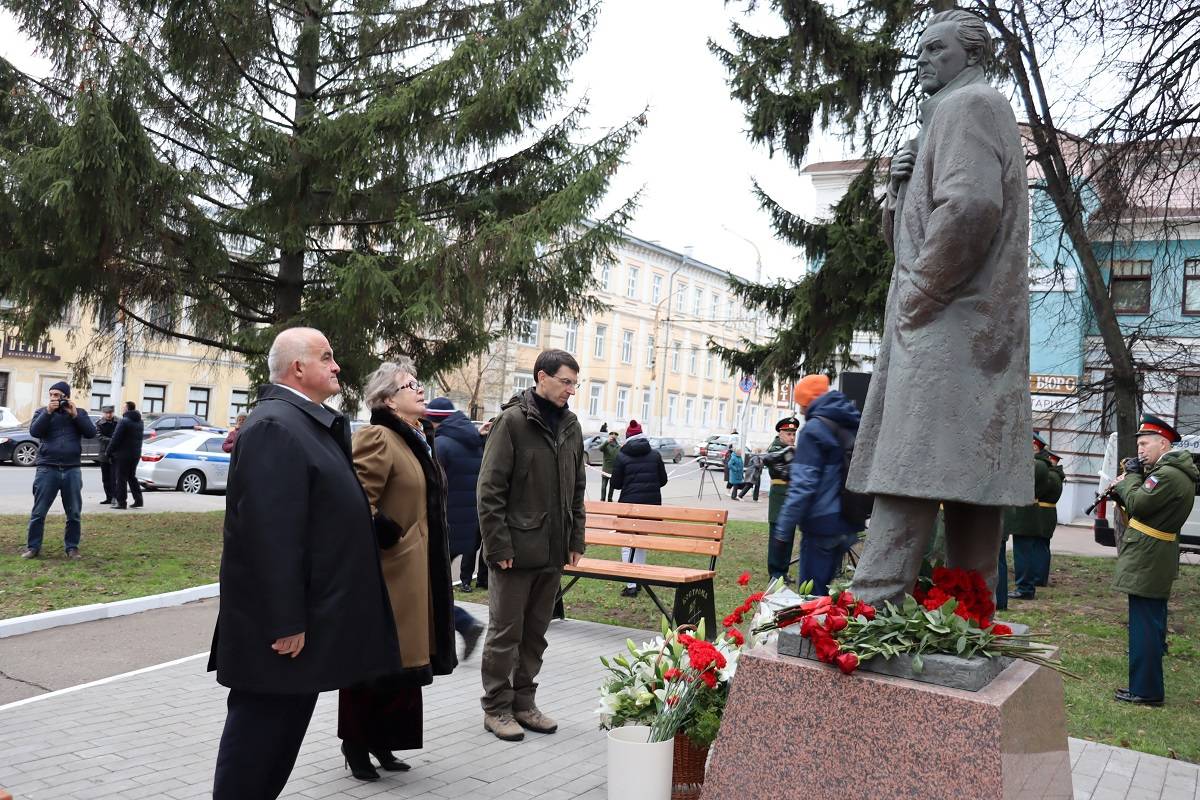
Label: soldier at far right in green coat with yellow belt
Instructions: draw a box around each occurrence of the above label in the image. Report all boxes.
[1109,414,1200,705]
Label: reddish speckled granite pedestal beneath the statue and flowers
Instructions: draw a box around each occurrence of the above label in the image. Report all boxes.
[702,644,1072,800]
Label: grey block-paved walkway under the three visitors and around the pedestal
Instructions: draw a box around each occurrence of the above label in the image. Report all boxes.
[0,604,1200,800]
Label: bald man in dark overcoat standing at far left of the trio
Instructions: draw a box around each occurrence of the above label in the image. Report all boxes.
[209,327,401,800]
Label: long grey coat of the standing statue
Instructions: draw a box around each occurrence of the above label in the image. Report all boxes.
[848,67,1033,505]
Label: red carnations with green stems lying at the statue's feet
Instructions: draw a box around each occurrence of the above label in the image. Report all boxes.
[754,567,1076,678]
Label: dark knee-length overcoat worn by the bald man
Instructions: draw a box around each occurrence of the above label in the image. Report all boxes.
[209,384,400,694]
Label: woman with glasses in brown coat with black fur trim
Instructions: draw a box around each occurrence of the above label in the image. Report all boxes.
[337,360,457,781]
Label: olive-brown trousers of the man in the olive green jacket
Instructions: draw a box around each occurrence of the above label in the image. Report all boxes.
[480,566,563,715]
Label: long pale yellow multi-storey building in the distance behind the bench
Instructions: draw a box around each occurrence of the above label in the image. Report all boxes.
[448,231,790,446]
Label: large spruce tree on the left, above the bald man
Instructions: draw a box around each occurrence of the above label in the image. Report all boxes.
[0,0,641,400]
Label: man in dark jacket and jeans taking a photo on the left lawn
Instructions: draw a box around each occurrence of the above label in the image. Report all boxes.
[20,380,96,559]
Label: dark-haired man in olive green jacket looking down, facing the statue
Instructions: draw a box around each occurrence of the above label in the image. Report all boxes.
[476,350,587,741]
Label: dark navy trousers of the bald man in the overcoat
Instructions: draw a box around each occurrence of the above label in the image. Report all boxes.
[212,690,317,800]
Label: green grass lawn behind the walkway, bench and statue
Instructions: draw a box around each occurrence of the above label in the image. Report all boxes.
[0,511,1200,762]
